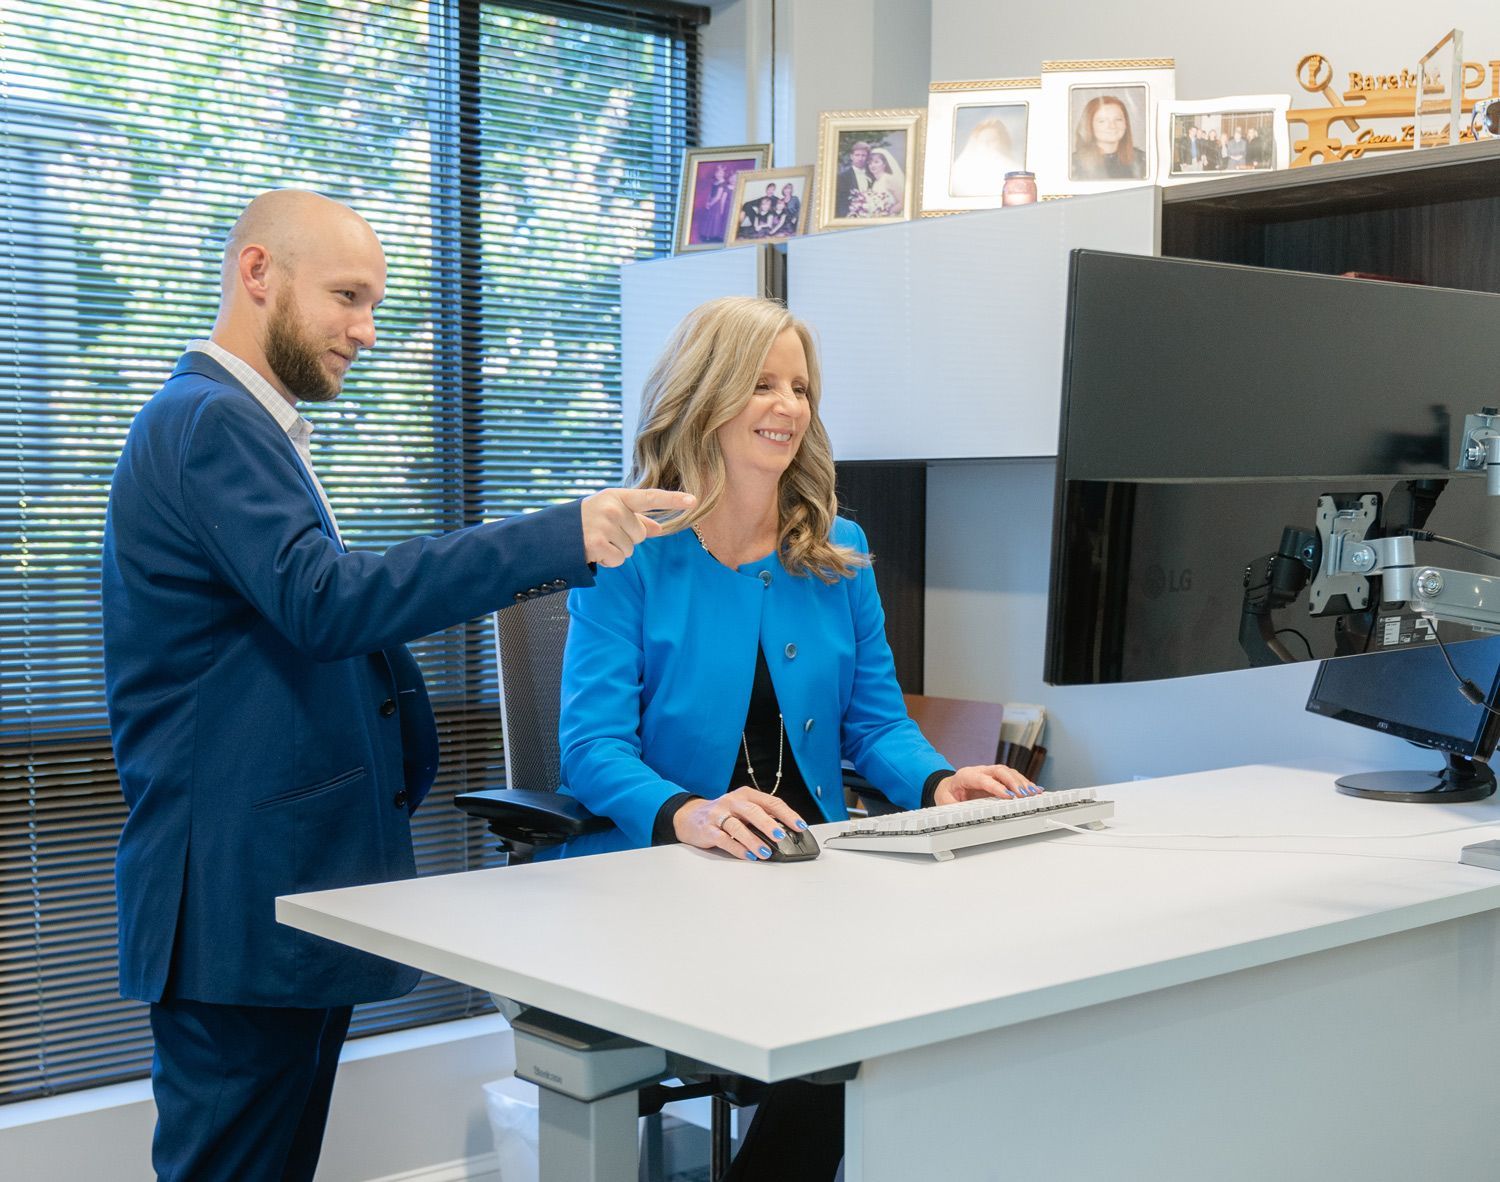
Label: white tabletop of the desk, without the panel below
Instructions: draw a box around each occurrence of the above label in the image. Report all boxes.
[276,767,1500,1080]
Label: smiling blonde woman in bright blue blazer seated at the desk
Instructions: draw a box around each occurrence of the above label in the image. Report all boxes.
[560,297,1040,1182]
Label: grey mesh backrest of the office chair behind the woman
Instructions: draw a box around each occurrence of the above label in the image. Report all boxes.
[495,594,567,792]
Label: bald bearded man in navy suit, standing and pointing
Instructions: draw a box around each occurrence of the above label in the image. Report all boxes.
[102,191,692,1182]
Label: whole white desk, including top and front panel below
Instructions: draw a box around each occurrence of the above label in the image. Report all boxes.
[278,767,1500,1182]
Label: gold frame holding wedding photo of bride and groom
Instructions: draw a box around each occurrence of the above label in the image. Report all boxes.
[815,107,927,230]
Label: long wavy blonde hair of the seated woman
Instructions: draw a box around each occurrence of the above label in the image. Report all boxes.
[630,296,869,584]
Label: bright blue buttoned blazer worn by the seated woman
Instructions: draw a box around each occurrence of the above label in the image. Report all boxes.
[560,518,948,854]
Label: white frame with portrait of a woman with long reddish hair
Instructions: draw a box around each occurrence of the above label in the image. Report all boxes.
[1034,57,1176,197]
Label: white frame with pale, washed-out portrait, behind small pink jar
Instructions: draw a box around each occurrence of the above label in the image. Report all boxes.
[921,78,1041,218]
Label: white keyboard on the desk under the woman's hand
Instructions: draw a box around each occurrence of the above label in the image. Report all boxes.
[824,788,1115,863]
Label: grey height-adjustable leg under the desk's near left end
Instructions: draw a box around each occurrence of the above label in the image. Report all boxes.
[510,1010,666,1182]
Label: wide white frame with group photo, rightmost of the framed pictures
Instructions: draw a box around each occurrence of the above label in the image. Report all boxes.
[1157,95,1292,185]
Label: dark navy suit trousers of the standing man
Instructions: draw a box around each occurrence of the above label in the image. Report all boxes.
[152,999,351,1182]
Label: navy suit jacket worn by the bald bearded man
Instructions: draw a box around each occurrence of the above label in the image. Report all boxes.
[102,353,593,1007]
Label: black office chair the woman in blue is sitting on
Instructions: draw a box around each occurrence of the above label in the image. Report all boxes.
[453,596,765,1179]
